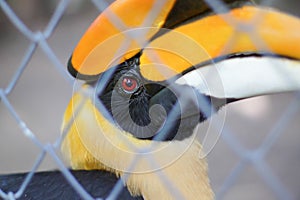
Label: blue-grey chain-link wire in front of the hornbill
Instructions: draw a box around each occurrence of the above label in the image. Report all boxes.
[0,0,300,199]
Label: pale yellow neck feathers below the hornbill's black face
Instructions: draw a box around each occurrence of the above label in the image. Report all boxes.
[62,90,213,199]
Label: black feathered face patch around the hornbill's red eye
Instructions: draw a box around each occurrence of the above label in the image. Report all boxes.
[97,55,218,141]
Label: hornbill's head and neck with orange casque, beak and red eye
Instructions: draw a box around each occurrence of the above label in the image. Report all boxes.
[0,0,300,199]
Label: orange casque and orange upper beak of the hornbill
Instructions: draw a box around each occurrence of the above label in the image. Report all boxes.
[69,0,300,84]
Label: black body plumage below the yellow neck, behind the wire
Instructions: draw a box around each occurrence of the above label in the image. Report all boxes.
[0,170,143,200]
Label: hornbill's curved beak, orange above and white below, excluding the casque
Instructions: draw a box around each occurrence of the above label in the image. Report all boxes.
[141,6,300,99]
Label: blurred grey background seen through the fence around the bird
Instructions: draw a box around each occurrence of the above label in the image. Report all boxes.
[0,0,300,199]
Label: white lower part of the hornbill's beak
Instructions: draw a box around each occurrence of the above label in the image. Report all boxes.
[177,55,300,99]
